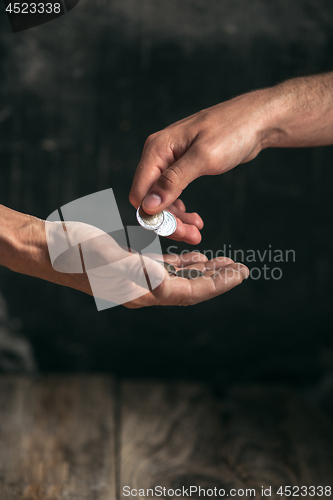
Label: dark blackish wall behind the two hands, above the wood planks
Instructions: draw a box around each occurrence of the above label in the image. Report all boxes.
[0,0,333,398]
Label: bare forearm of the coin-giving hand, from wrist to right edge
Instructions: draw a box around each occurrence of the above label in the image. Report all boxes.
[259,72,333,148]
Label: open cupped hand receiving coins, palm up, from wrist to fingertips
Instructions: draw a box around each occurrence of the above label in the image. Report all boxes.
[40,222,248,308]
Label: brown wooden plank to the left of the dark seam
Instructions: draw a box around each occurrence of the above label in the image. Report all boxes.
[0,376,115,500]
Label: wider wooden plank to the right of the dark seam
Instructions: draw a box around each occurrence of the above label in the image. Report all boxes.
[120,382,333,499]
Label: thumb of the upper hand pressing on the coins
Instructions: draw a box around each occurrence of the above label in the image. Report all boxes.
[142,148,202,214]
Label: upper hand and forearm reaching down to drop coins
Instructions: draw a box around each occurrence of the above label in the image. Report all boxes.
[130,73,333,243]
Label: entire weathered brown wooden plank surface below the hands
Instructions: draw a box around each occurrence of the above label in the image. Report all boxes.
[0,375,333,500]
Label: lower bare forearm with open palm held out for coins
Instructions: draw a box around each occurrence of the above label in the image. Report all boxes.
[0,205,249,309]
